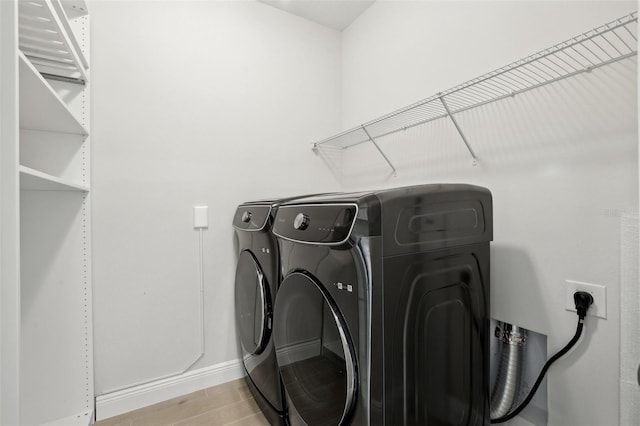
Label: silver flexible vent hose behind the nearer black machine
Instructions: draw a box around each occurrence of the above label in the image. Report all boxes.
[491,323,527,419]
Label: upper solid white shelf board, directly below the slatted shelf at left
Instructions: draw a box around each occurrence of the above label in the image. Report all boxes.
[19,52,89,135]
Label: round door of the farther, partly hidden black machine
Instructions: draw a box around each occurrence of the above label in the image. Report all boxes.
[235,250,271,355]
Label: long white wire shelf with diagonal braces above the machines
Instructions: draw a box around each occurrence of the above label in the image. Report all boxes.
[312,11,638,173]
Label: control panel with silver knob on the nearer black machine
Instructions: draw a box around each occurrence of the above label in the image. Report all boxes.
[273,204,358,245]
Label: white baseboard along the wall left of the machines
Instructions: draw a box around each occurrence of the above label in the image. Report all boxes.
[96,359,245,420]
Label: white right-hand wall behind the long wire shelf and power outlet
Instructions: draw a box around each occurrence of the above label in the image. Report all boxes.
[340,1,638,426]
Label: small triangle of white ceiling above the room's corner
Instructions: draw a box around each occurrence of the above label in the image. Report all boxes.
[258,0,375,31]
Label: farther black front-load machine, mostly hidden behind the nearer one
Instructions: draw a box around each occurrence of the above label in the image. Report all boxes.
[233,201,286,425]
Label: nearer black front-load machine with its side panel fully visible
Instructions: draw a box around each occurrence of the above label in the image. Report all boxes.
[273,184,493,426]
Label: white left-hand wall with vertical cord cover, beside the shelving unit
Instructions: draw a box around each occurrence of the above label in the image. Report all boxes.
[89,1,341,395]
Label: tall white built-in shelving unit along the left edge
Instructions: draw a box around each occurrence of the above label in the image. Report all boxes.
[0,0,94,425]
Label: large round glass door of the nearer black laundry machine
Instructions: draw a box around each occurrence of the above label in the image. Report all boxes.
[273,272,357,426]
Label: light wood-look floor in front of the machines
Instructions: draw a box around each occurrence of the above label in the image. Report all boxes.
[96,379,269,426]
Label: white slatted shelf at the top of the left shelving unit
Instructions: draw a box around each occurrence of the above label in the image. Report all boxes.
[18,0,88,84]
